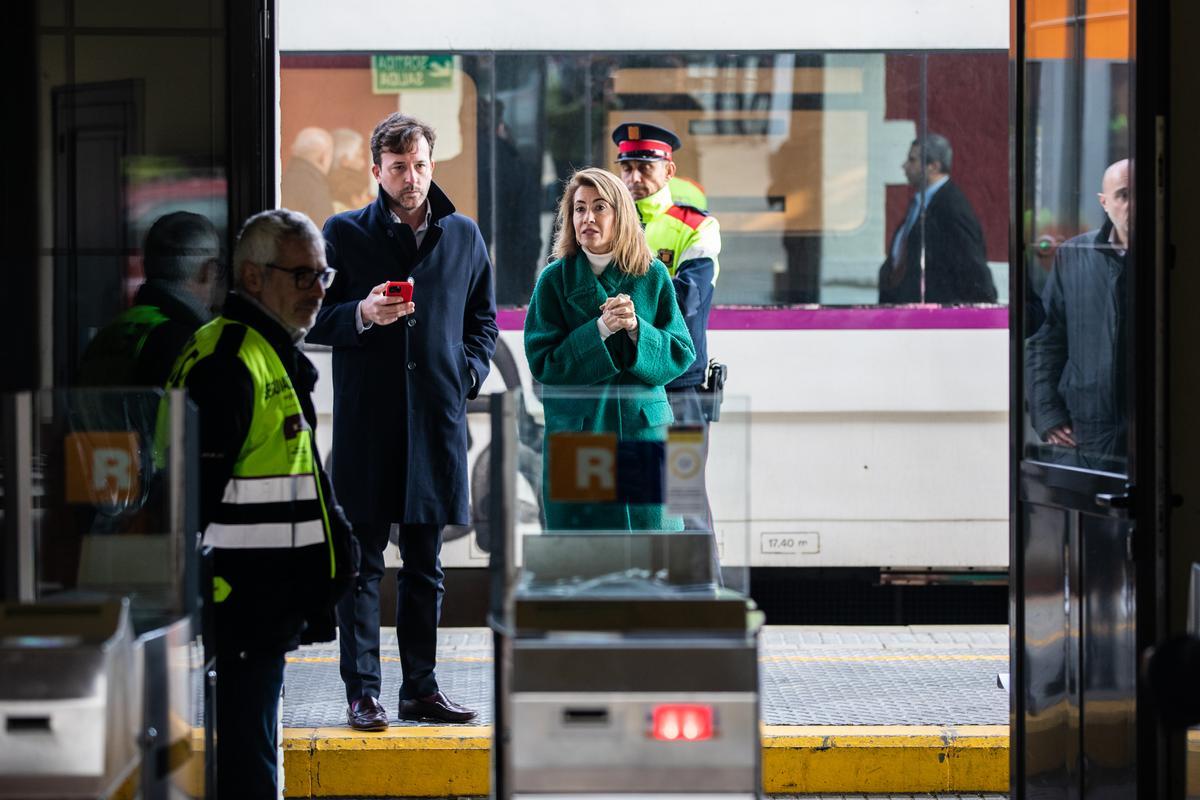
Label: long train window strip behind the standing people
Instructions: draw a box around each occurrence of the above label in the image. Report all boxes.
[280,52,1008,306]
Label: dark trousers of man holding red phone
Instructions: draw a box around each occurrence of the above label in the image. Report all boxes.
[337,522,445,703]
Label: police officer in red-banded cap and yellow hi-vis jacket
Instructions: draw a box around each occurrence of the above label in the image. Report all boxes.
[612,122,721,530]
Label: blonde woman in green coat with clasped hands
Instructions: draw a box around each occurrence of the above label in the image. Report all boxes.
[524,168,696,530]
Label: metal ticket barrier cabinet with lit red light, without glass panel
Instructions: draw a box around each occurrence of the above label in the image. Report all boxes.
[508,534,761,800]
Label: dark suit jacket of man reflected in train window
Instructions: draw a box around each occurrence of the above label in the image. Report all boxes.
[880,180,996,303]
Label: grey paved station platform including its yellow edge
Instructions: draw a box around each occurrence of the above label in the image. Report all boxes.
[276,625,1009,798]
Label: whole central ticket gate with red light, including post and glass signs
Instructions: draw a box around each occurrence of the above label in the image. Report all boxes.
[487,387,763,800]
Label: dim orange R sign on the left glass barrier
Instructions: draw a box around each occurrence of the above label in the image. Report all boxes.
[64,431,142,506]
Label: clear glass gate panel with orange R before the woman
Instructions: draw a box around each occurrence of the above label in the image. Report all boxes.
[508,384,748,596]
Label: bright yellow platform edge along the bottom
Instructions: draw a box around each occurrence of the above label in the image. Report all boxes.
[276,726,1008,798]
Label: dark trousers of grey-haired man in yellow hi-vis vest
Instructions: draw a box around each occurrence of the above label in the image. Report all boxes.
[216,652,284,800]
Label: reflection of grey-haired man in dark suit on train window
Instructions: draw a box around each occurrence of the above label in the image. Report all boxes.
[880,133,996,303]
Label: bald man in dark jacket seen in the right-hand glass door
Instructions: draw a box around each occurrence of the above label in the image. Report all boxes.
[1025,160,1129,469]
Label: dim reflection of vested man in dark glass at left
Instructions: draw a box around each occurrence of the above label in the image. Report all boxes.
[77,211,222,386]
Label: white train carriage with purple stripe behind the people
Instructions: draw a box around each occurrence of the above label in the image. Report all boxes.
[278,0,1008,618]
